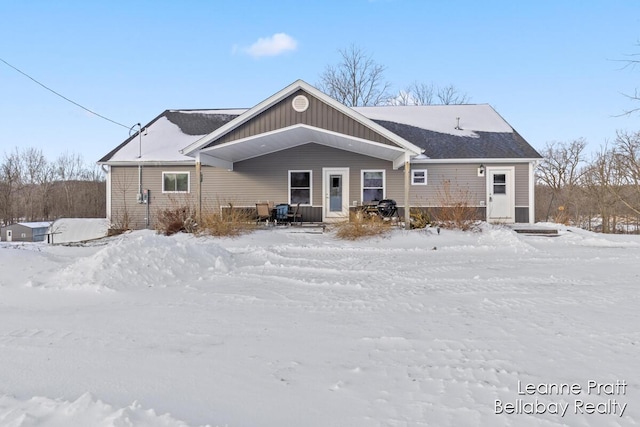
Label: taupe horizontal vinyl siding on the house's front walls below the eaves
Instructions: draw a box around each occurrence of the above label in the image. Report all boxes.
[111,147,529,228]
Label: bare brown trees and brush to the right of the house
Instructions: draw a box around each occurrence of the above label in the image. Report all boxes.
[536,131,640,233]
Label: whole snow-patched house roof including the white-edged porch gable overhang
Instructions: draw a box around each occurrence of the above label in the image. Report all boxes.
[99,80,541,164]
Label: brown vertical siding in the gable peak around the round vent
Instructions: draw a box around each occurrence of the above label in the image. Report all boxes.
[210,90,395,150]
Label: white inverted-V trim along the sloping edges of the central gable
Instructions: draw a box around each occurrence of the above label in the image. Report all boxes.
[180,80,424,156]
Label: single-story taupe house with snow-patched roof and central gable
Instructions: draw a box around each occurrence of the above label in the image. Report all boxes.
[98,80,541,228]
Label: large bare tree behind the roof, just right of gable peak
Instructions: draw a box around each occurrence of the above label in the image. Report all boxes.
[317,45,391,107]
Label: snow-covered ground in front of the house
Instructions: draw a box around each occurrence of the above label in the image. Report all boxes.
[0,226,640,427]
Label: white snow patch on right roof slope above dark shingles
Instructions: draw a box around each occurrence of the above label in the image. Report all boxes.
[353,104,513,136]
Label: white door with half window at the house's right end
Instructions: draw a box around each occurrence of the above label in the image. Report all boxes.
[487,167,515,223]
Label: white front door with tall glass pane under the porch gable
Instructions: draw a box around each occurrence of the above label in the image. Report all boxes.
[322,168,349,222]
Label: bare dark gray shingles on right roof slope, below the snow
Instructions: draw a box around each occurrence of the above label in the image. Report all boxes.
[374,120,542,159]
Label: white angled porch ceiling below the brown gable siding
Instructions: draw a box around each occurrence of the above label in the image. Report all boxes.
[200,125,405,166]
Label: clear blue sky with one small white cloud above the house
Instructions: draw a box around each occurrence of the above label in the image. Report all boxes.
[0,0,640,162]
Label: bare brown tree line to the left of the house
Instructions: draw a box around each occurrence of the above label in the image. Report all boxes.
[0,148,106,225]
